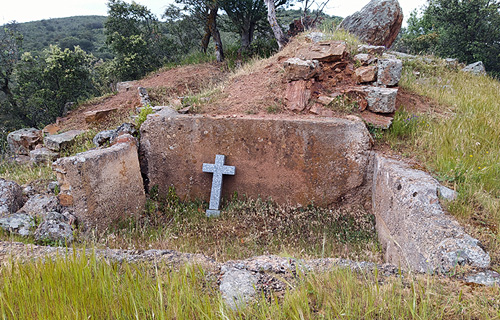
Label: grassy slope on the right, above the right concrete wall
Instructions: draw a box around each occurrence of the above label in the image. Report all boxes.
[387,60,500,267]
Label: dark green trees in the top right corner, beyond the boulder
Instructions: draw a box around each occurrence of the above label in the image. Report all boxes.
[401,0,500,73]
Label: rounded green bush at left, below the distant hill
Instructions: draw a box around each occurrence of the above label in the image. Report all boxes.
[15,46,99,127]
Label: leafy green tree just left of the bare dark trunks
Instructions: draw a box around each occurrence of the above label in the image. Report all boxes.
[105,0,169,80]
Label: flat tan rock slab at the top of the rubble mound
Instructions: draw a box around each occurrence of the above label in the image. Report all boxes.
[295,41,346,62]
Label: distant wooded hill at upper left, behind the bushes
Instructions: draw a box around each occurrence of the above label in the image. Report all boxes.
[14,16,113,59]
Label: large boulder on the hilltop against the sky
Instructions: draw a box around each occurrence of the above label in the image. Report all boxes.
[339,0,403,48]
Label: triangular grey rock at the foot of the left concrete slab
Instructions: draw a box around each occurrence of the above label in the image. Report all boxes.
[34,212,74,246]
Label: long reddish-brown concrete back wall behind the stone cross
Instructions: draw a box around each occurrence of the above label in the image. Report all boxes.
[141,114,371,206]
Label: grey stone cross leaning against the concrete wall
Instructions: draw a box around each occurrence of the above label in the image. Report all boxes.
[203,154,236,217]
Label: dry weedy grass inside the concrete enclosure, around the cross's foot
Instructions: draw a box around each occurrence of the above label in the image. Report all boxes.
[93,191,381,262]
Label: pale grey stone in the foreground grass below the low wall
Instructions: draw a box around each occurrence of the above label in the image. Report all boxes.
[219,266,258,310]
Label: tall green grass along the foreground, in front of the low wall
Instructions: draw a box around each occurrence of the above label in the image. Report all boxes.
[0,255,500,320]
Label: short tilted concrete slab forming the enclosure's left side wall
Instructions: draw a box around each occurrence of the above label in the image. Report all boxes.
[53,135,146,230]
